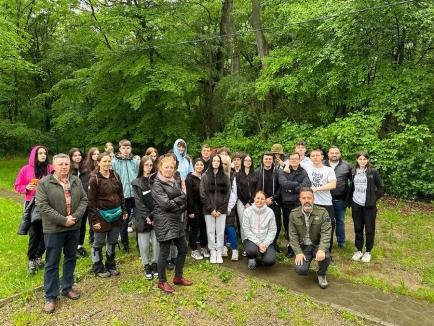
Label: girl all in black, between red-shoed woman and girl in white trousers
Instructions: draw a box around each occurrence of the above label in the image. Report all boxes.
[185,158,209,260]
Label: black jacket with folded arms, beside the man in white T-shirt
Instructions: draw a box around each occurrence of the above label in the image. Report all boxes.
[279,165,312,204]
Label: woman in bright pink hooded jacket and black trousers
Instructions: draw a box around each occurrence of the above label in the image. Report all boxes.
[15,145,53,274]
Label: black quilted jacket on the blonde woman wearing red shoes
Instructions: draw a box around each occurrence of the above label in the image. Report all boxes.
[151,175,187,242]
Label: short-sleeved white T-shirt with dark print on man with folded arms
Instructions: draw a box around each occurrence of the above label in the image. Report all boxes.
[306,164,336,206]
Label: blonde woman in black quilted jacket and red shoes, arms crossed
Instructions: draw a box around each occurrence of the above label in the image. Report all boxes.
[151,157,193,293]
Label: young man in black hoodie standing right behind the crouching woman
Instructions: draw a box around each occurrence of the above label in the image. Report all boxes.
[256,152,282,252]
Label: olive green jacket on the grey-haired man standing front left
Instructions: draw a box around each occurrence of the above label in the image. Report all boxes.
[36,174,87,233]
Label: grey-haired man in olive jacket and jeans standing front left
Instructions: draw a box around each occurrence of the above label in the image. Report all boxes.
[36,154,87,313]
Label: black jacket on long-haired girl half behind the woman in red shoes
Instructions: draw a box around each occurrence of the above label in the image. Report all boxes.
[131,173,157,233]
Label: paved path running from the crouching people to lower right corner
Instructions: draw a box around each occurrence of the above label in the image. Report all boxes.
[224,259,434,326]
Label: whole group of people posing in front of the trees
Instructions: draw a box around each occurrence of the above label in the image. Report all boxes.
[15,139,383,313]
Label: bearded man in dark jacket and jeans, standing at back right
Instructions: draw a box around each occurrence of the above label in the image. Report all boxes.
[324,146,351,248]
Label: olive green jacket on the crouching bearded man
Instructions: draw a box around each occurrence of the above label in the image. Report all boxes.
[289,205,332,255]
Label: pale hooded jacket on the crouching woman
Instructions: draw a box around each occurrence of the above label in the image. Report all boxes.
[242,204,277,247]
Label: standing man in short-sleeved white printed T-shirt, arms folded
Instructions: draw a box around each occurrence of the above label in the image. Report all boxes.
[306,149,336,263]
